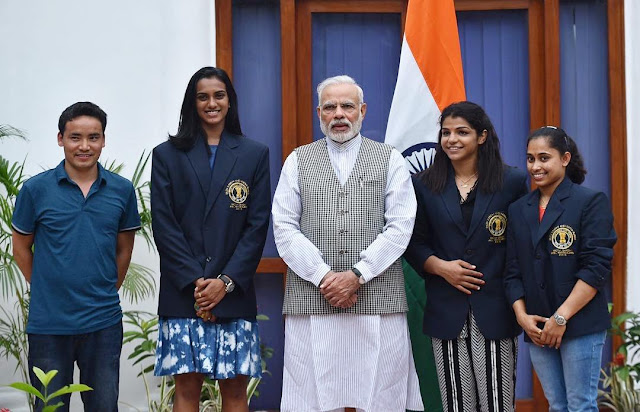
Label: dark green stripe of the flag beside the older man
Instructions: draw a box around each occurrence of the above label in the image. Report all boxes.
[402,259,443,412]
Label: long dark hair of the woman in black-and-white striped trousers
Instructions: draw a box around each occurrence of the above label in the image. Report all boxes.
[420,101,504,193]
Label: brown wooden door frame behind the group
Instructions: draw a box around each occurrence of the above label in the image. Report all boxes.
[215,0,628,411]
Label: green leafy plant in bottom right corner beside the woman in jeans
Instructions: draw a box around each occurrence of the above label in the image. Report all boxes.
[598,312,640,412]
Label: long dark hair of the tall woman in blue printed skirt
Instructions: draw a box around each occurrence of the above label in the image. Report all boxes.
[169,67,242,150]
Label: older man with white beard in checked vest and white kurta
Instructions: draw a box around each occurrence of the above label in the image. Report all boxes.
[273,76,423,412]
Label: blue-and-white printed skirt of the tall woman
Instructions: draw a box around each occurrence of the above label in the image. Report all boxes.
[154,317,262,379]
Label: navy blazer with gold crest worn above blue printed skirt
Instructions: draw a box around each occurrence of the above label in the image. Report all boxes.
[151,132,271,318]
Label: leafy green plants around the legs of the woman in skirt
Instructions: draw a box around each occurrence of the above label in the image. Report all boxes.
[123,311,273,412]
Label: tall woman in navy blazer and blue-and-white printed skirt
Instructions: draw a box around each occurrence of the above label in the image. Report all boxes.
[151,67,271,411]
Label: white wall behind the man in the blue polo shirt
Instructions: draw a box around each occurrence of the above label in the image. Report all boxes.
[0,0,215,411]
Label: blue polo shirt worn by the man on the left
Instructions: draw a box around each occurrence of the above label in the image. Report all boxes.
[12,161,140,335]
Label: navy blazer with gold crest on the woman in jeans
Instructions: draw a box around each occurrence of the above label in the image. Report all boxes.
[505,177,617,340]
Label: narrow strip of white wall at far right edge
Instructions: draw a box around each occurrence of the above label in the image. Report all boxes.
[624,0,640,311]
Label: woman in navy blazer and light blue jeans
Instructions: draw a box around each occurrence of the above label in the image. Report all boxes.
[505,126,616,411]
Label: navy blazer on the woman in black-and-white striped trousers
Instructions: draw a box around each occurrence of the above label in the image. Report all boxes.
[405,166,528,339]
